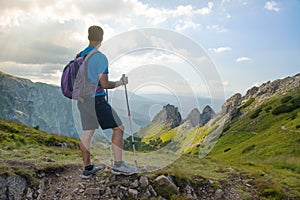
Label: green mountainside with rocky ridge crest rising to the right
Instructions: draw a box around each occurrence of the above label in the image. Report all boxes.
[122,75,300,199]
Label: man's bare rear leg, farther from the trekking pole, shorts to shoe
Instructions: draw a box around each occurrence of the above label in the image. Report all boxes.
[80,130,95,167]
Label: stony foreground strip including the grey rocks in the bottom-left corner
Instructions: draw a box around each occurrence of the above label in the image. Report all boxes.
[0,161,258,200]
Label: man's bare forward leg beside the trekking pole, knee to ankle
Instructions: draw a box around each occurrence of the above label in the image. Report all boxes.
[111,125,124,162]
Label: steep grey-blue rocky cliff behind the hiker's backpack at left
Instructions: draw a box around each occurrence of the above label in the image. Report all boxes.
[0,72,77,137]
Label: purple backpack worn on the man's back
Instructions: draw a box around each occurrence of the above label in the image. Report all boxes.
[61,51,102,101]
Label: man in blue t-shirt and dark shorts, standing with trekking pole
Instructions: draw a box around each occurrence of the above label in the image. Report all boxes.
[78,26,135,178]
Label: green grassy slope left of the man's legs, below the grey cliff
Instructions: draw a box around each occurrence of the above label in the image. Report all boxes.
[0,119,80,174]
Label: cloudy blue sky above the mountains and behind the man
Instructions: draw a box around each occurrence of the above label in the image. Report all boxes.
[0,0,300,98]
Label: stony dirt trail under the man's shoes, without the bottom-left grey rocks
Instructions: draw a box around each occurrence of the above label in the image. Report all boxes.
[41,166,246,200]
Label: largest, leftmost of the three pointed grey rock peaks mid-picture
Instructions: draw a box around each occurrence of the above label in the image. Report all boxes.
[152,104,181,128]
